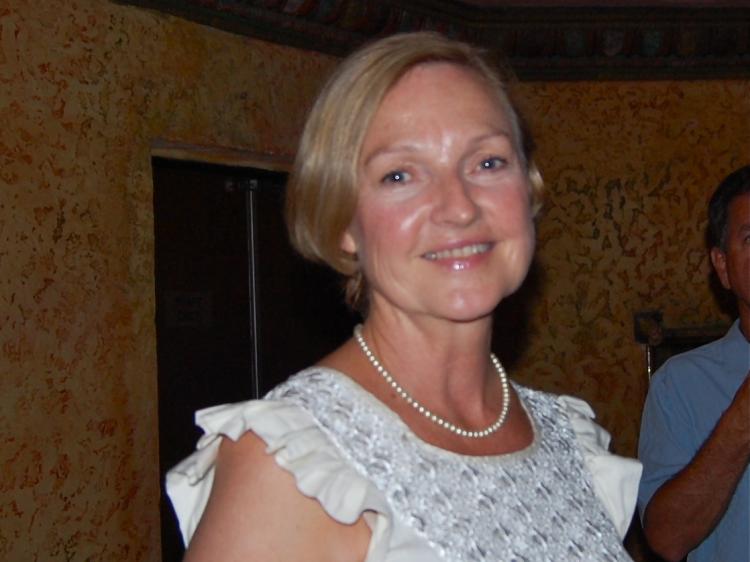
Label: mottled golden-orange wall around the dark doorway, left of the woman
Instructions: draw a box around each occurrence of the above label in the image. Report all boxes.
[0,0,331,562]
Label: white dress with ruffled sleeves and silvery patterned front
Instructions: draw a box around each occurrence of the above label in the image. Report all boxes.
[167,367,641,562]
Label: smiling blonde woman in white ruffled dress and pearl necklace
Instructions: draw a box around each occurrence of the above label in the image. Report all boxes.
[168,33,640,562]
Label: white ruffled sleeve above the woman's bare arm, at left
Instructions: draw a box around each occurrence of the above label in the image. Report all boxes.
[166,400,434,562]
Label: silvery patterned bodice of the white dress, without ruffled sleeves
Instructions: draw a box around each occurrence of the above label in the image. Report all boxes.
[267,368,630,562]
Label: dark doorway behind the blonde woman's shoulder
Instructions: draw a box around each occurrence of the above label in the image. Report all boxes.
[152,158,357,562]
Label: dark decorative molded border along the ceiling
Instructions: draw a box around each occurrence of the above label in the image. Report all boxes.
[114,0,750,81]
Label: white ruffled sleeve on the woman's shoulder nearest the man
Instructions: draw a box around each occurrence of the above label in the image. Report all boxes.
[558,396,643,538]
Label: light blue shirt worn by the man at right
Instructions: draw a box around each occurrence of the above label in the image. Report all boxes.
[638,321,750,562]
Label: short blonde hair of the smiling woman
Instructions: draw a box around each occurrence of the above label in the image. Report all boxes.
[286,32,543,308]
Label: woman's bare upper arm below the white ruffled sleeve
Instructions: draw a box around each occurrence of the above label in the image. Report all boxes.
[184,433,370,562]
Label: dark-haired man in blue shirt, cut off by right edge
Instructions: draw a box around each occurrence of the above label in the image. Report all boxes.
[638,166,750,562]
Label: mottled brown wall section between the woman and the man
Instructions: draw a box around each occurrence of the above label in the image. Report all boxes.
[518,81,750,455]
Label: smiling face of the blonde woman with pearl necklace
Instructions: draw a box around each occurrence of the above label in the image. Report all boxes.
[342,63,534,321]
